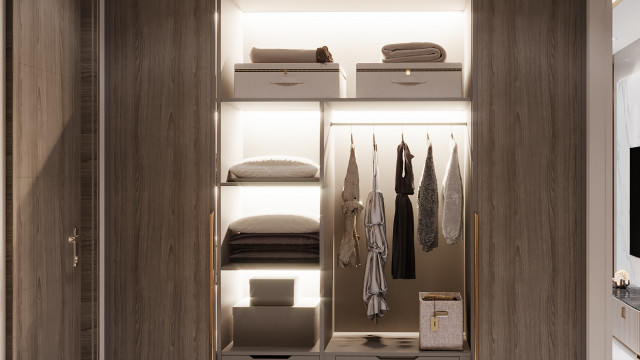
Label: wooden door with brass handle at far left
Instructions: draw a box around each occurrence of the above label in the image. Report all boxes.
[7,0,82,360]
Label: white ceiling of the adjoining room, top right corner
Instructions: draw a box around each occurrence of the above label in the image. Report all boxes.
[613,0,640,54]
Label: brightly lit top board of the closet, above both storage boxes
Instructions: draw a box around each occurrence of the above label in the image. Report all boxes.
[228,0,469,12]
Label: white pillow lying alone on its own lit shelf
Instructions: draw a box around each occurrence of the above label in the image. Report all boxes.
[229,156,320,178]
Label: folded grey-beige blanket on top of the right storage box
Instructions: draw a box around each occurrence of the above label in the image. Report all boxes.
[382,42,447,63]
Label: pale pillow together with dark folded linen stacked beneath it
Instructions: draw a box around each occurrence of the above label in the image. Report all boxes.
[229,214,320,263]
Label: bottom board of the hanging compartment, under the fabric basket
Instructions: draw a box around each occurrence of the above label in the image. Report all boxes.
[325,332,471,357]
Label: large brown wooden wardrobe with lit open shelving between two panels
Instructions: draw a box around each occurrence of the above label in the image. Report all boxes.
[105,0,585,360]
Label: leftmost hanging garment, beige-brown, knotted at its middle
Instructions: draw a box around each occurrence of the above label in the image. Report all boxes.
[338,143,363,268]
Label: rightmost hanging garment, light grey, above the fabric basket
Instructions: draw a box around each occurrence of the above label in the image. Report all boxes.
[442,140,464,244]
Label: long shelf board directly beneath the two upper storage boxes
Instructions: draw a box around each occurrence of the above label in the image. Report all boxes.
[220,98,471,111]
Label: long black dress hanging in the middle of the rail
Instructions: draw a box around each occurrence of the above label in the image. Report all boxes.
[391,141,416,279]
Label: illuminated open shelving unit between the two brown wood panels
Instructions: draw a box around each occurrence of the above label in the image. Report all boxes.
[214,0,474,360]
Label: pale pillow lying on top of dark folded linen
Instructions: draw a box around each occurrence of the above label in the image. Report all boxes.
[229,214,320,234]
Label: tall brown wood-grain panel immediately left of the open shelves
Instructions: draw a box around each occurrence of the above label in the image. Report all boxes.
[106,0,213,360]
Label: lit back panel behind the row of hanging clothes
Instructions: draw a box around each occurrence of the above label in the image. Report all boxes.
[332,111,470,332]
